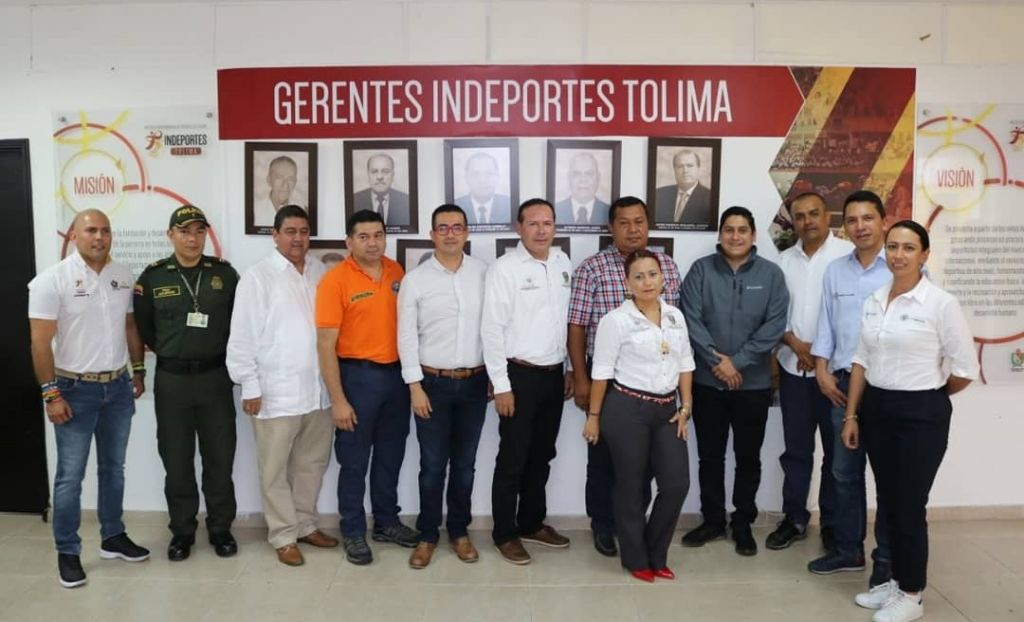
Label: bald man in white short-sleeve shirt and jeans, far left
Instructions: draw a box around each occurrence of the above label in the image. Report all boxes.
[29,209,150,587]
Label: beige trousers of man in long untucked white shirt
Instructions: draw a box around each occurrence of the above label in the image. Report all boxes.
[252,410,334,548]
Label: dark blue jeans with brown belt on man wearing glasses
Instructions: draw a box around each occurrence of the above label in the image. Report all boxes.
[415,373,487,543]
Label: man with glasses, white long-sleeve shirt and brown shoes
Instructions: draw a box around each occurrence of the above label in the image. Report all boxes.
[398,205,487,569]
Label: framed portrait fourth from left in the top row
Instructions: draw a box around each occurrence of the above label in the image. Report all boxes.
[547,139,623,234]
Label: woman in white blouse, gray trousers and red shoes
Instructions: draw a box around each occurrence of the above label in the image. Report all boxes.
[583,250,693,582]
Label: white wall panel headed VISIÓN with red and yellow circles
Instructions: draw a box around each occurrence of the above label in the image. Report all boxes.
[914,103,1024,384]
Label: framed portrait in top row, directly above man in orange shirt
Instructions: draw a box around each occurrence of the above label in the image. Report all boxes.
[343,140,420,234]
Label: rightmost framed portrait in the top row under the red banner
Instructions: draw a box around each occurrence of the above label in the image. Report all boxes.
[647,137,722,232]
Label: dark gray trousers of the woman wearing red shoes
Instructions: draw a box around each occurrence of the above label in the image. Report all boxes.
[601,388,690,571]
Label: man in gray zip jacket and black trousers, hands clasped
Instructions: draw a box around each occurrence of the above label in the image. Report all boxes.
[680,207,790,555]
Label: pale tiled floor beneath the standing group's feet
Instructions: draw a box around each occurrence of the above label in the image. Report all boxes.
[0,514,1024,622]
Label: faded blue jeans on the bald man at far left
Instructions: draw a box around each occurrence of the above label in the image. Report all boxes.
[53,373,135,555]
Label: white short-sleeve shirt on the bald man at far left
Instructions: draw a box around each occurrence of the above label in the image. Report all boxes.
[29,252,134,374]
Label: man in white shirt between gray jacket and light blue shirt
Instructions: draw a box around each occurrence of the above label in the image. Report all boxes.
[765,193,853,550]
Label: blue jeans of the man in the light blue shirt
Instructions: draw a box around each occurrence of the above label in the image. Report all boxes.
[831,372,892,563]
